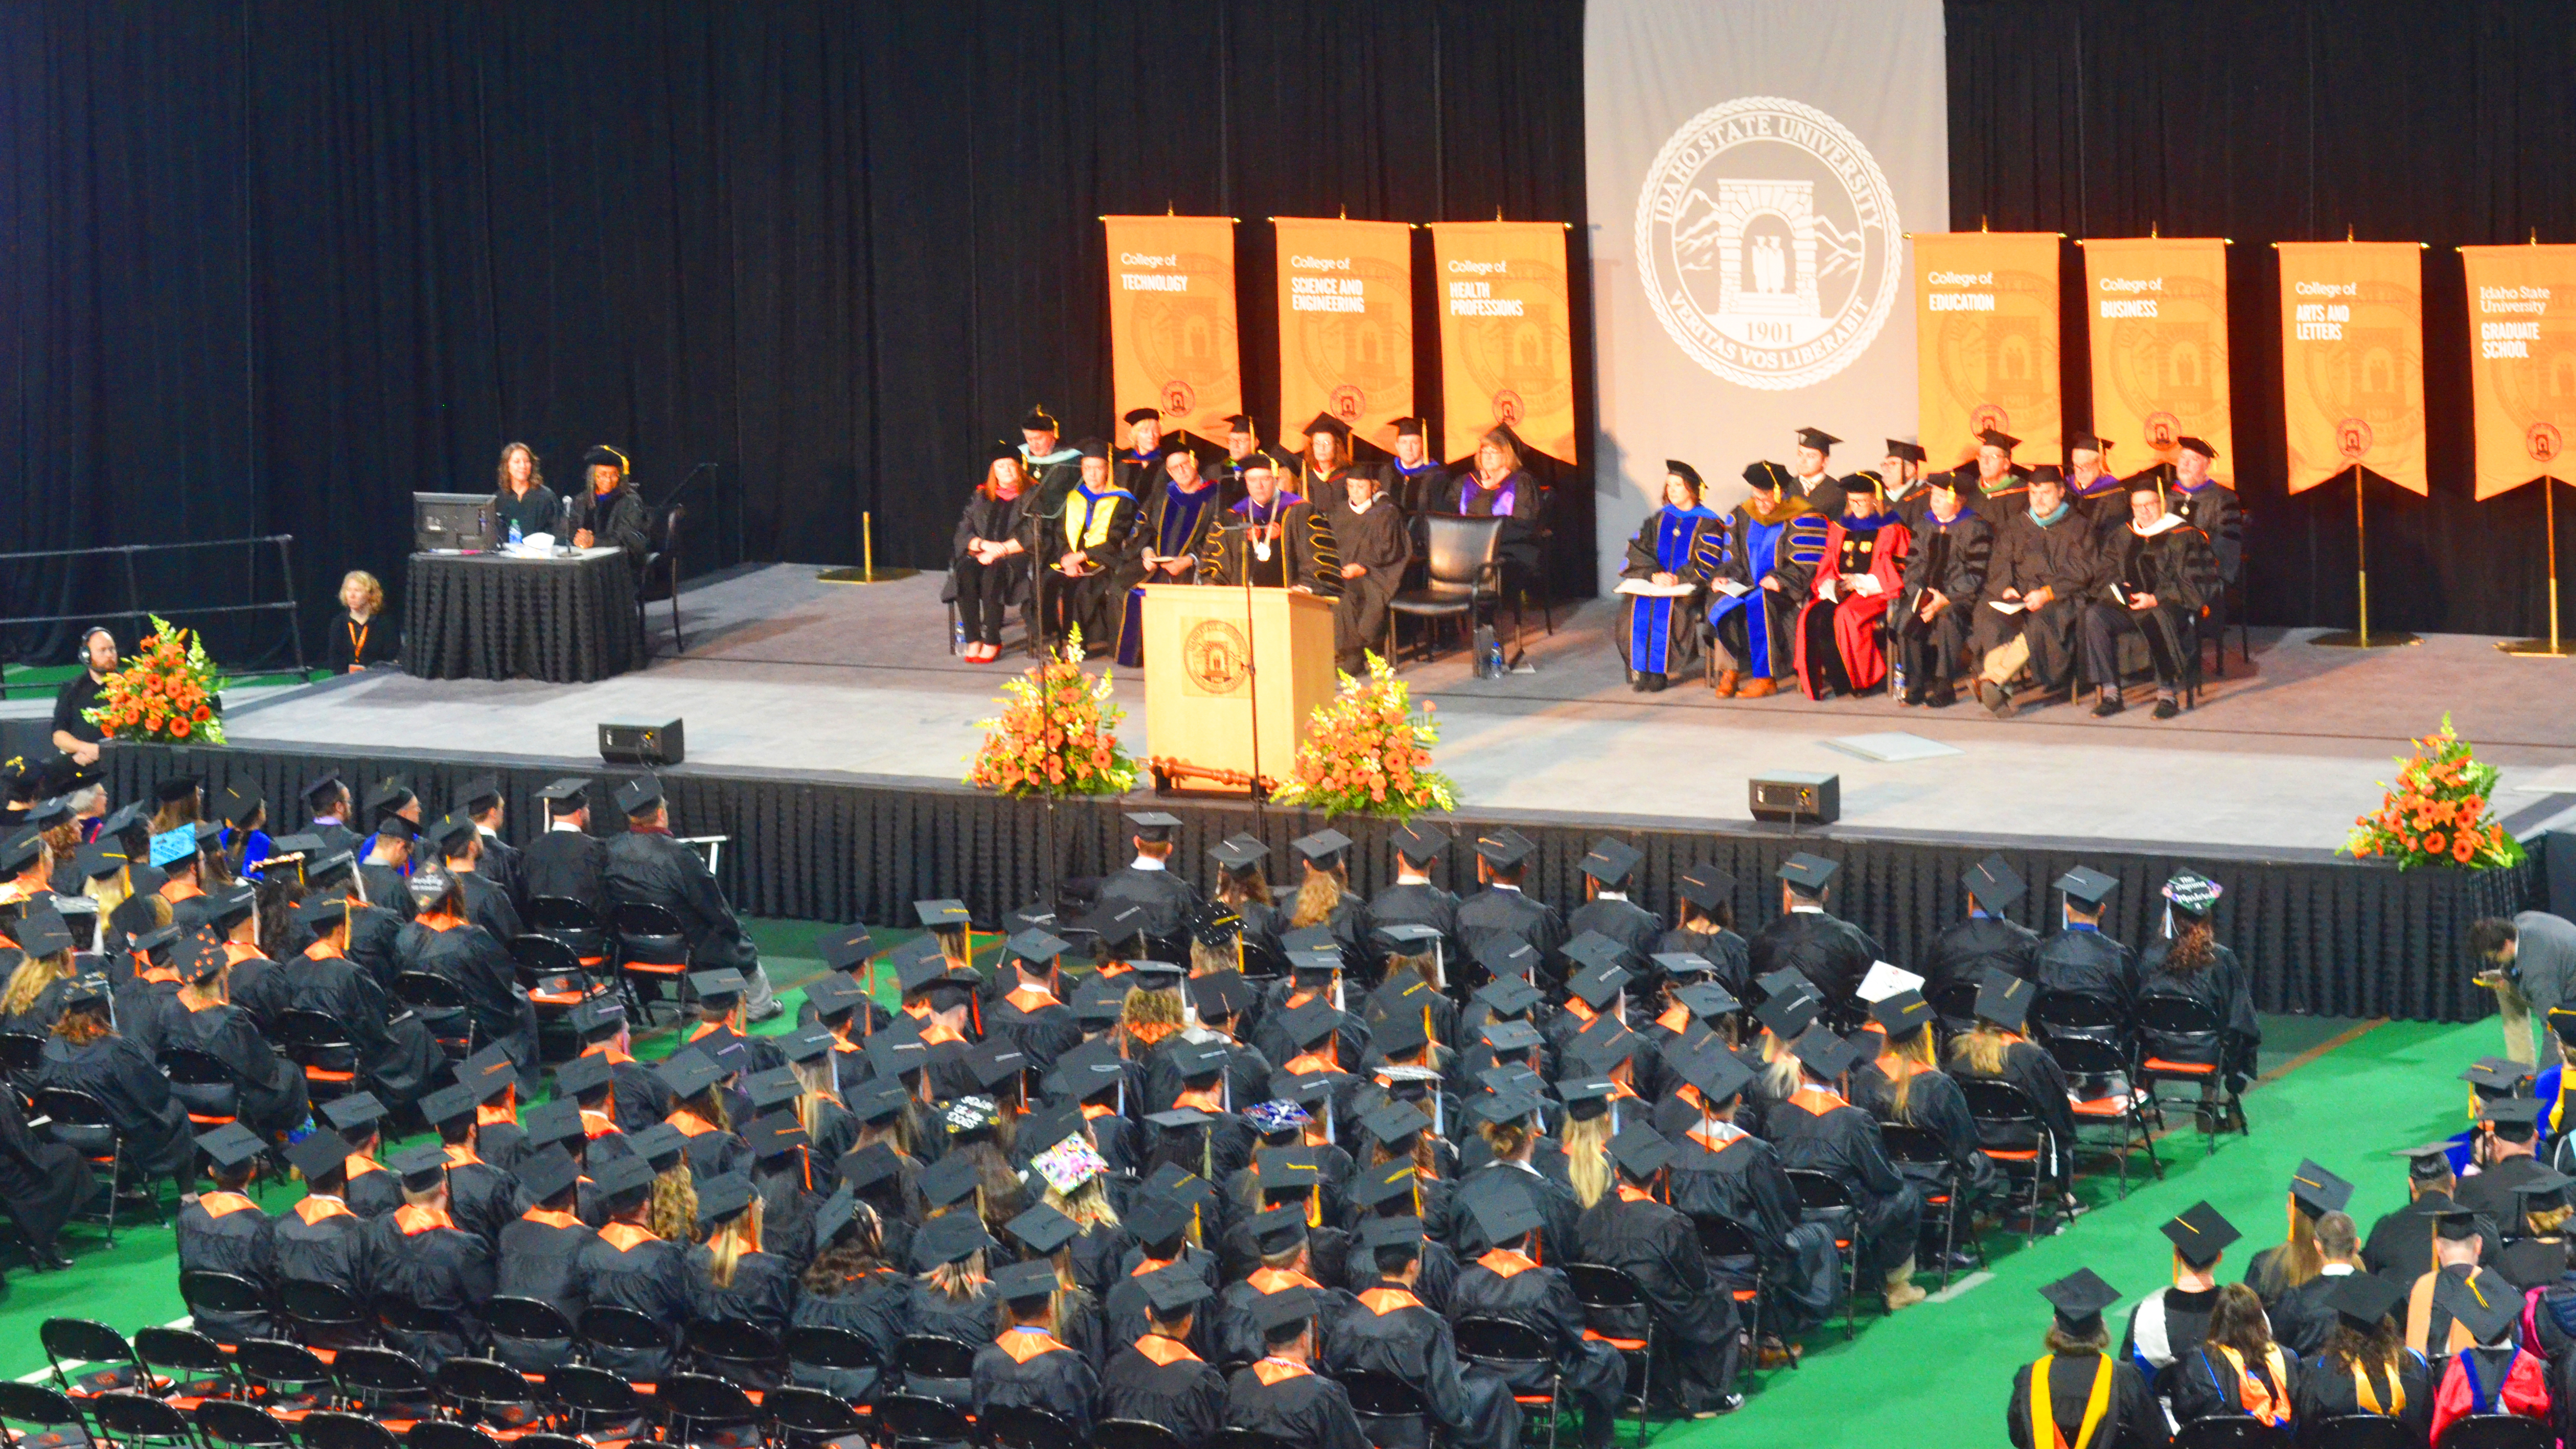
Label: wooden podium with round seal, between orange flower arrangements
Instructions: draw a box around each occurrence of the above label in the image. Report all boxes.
[1144,583,1335,794]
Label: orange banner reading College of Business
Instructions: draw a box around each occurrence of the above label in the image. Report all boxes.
[2082,237,2236,487]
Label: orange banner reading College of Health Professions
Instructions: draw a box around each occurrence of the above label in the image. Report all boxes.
[1432,222,1574,464]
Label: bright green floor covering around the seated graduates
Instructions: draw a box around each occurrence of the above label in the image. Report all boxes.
[0,953,2496,1449]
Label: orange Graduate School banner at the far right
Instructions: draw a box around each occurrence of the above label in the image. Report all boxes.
[2460,248,2576,498]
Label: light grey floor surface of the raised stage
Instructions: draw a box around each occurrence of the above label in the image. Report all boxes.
[95,565,2576,856]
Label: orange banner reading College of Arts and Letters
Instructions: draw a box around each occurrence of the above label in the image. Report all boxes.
[2277,243,2429,492]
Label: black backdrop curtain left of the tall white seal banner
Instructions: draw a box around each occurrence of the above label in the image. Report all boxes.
[0,0,1592,658]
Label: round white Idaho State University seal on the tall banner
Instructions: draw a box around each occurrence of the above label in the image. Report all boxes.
[1636,95,1904,392]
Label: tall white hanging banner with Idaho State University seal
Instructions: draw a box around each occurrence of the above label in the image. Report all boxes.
[1584,0,1950,591]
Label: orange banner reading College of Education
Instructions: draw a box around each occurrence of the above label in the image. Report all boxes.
[1914,232,2063,467]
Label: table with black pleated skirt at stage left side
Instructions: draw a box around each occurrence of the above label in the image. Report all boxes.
[402,549,644,683]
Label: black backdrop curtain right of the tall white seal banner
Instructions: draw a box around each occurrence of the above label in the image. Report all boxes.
[1945,0,2576,634]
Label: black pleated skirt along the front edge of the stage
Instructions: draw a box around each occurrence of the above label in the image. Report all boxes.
[106,745,2543,1021]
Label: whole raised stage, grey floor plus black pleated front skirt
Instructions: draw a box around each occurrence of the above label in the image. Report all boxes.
[10,565,2576,1018]
